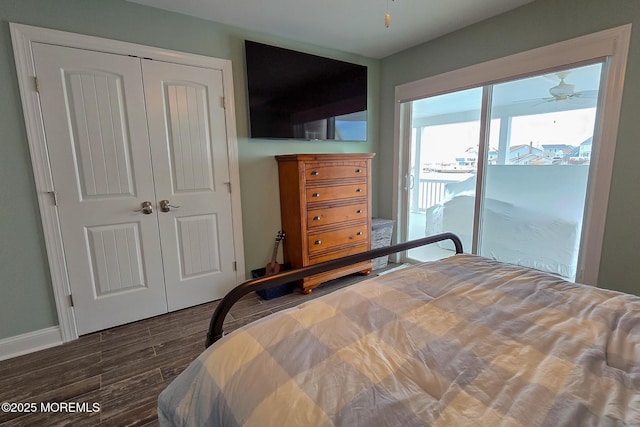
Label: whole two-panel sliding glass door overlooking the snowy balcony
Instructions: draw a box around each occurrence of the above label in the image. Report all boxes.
[401,63,602,280]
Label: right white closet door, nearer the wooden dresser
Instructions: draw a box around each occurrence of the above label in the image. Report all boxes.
[142,60,236,311]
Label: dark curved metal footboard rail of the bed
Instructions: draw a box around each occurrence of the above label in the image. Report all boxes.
[205,233,463,347]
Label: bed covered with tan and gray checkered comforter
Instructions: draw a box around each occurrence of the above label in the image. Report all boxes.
[158,235,640,426]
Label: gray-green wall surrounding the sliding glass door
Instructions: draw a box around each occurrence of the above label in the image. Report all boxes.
[378,0,640,295]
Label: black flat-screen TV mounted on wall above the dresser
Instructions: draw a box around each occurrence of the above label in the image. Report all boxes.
[245,40,367,141]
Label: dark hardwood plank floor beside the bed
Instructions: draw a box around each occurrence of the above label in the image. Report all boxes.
[0,270,394,426]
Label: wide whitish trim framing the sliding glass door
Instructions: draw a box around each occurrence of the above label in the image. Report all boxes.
[393,24,631,285]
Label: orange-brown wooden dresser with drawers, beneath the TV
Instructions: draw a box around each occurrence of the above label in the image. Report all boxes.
[276,153,375,293]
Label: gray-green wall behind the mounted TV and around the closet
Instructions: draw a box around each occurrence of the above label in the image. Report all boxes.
[0,0,380,339]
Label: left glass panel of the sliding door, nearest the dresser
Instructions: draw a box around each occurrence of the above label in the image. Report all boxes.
[406,88,482,260]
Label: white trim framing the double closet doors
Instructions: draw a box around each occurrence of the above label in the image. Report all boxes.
[9,23,245,342]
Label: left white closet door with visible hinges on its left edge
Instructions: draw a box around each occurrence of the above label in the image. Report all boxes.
[33,44,167,335]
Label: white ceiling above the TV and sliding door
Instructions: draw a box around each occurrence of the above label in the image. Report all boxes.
[129,0,533,58]
